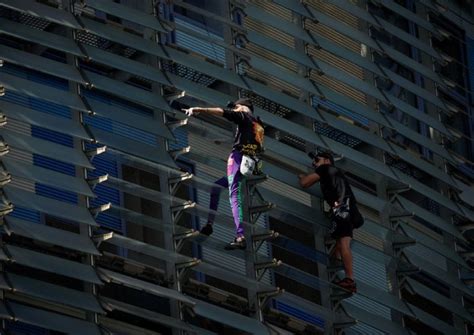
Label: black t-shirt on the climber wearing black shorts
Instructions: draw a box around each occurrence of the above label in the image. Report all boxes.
[314,164,355,207]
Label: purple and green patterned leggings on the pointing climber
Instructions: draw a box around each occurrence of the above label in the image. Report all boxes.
[207,151,244,237]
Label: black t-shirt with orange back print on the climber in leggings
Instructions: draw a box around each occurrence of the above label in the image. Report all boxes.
[223,109,264,156]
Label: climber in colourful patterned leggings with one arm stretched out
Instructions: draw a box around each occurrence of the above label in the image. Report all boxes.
[184,98,264,250]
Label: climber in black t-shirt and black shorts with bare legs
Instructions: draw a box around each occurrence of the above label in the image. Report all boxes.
[298,152,363,292]
